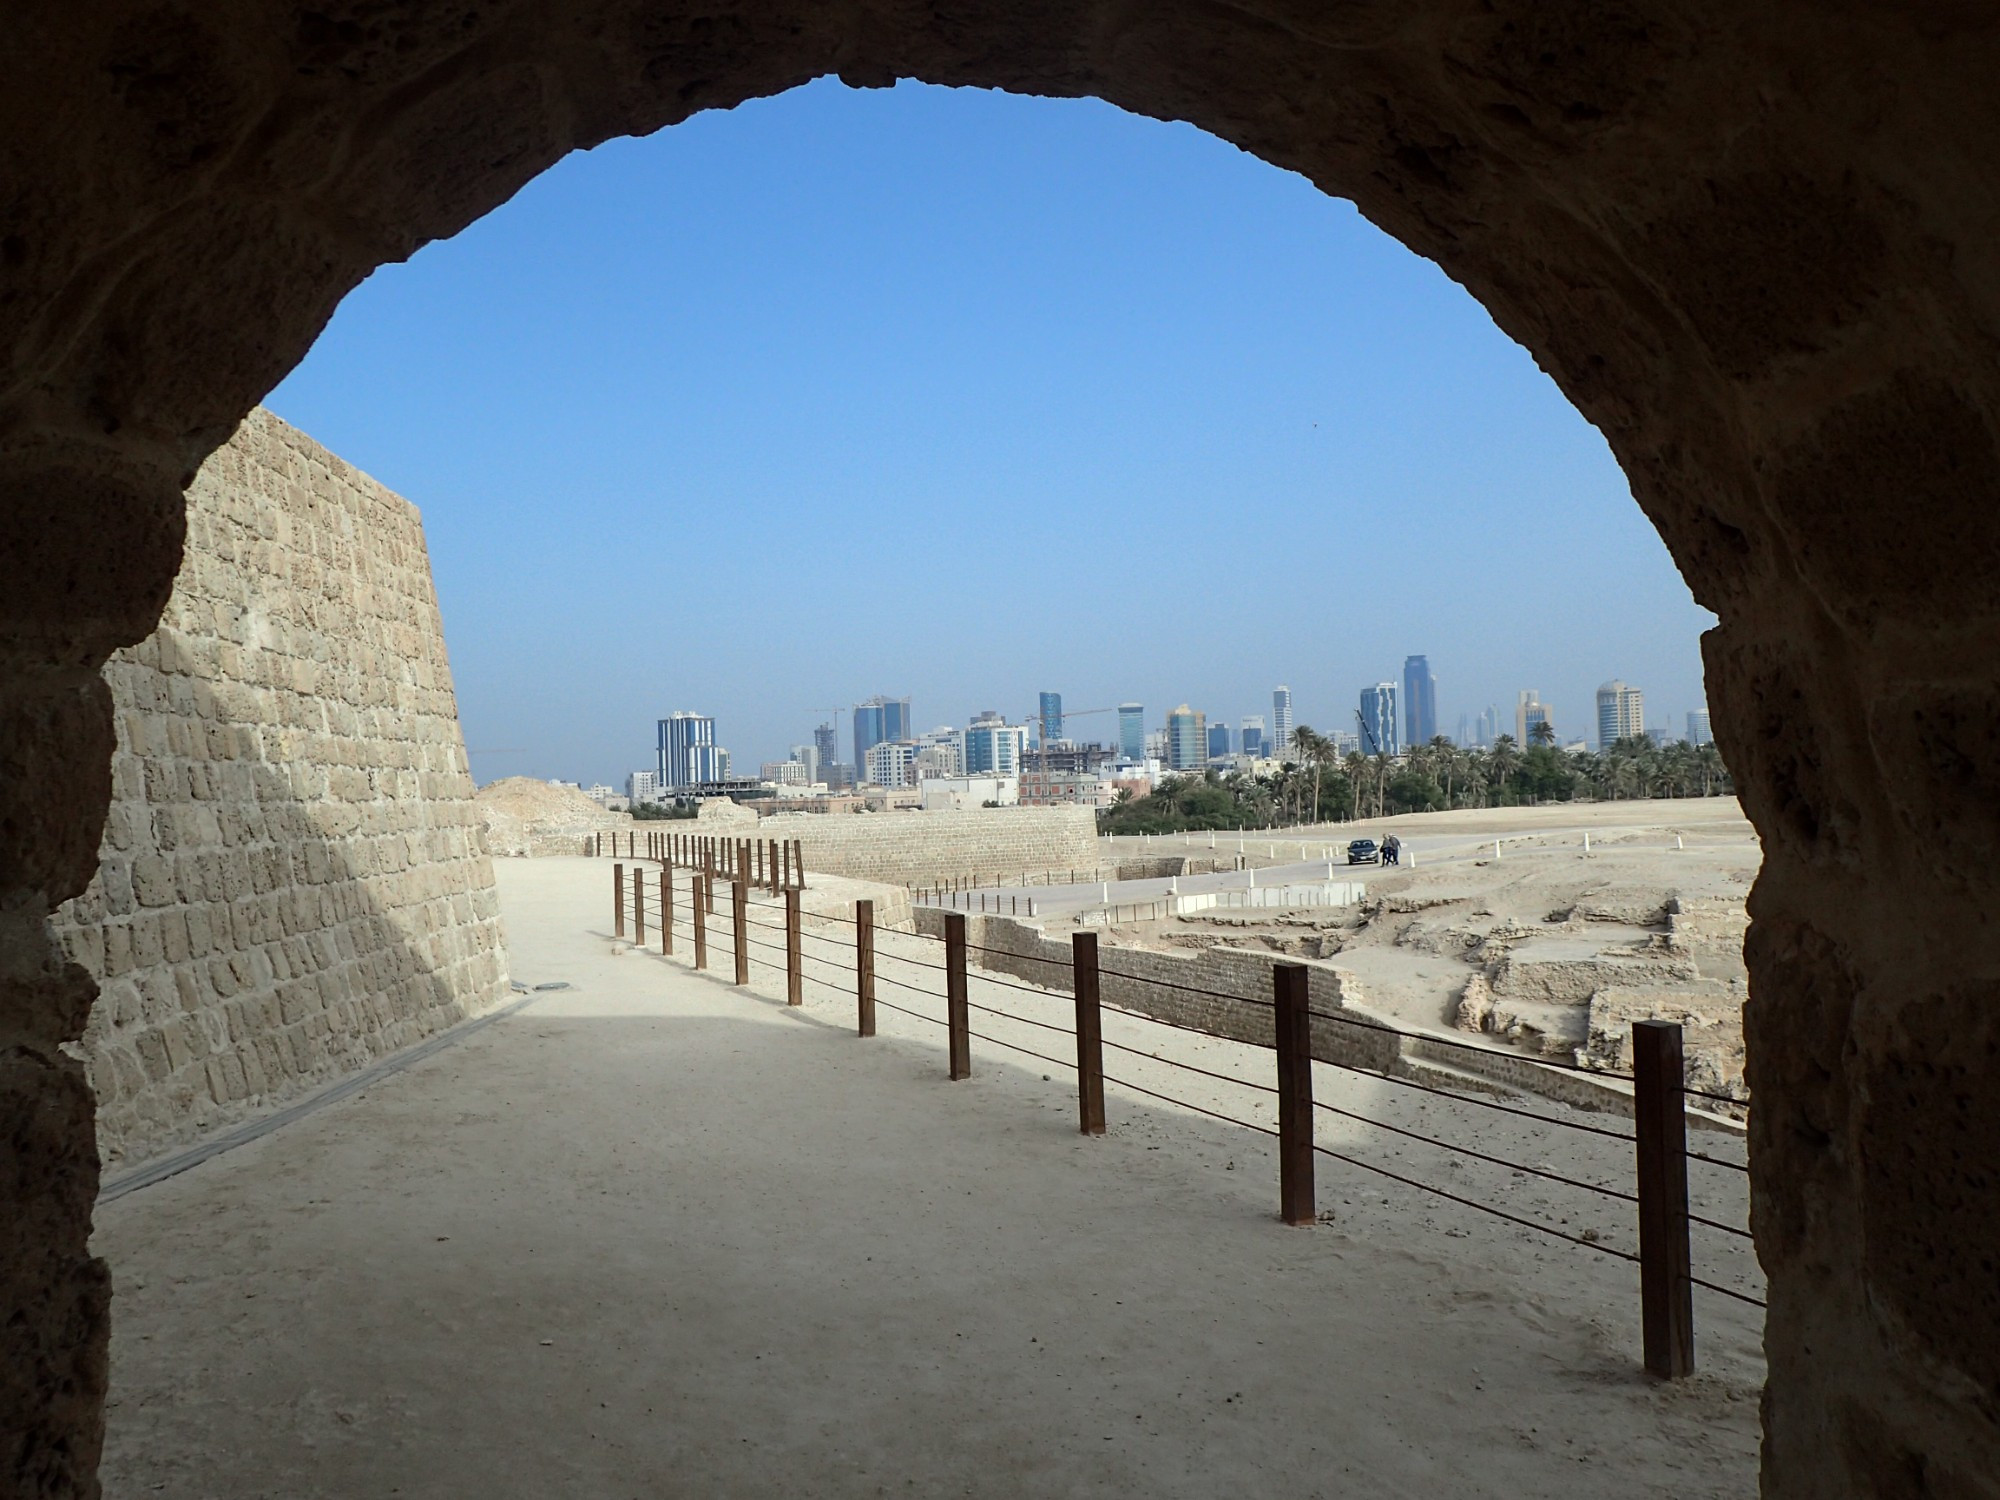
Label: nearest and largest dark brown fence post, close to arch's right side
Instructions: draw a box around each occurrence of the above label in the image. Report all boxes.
[1632,1020,1694,1380]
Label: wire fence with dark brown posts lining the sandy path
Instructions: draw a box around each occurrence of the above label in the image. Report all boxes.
[614,846,1764,1376]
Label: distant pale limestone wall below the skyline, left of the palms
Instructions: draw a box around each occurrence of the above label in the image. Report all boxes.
[744,808,1098,884]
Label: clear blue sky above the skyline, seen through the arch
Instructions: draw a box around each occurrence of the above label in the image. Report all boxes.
[268,80,1714,786]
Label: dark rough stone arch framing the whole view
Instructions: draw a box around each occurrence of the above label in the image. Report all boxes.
[0,0,2000,1496]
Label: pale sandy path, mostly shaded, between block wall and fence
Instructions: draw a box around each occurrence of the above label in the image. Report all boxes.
[98,860,1762,1500]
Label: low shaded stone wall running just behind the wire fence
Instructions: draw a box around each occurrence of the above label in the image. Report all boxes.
[916,906,1400,1072]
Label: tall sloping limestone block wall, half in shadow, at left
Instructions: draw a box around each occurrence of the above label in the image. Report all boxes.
[52,410,506,1162]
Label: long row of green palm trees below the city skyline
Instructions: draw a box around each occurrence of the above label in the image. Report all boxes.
[1100,722,1736,834]
